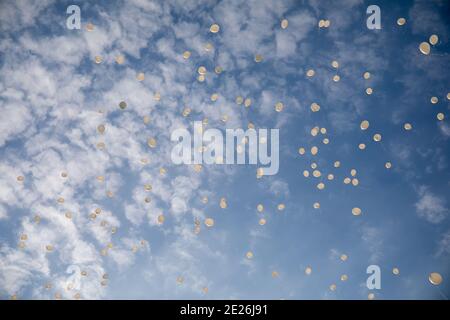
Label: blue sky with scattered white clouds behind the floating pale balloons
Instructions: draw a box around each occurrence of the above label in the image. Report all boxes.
[0,0,450,299]
